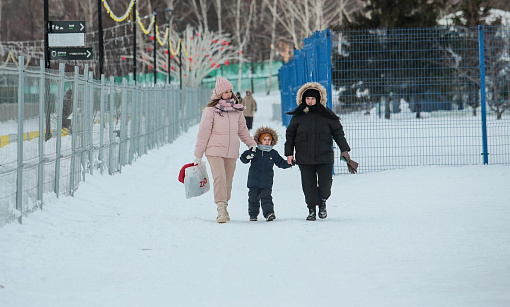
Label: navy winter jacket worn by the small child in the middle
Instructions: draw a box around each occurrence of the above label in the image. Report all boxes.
[241,148,291,188]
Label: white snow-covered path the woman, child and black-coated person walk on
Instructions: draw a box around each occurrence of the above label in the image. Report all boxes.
[0,91,510,306]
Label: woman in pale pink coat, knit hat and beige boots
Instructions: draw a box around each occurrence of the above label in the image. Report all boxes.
[193,77,257,223]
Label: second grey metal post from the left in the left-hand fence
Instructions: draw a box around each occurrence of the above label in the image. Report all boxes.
[37,61,45,210]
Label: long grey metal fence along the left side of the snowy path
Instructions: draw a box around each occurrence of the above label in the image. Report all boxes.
[0,58,210,223]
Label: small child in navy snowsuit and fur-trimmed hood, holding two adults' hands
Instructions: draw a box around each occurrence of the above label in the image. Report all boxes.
[241,127,292,222]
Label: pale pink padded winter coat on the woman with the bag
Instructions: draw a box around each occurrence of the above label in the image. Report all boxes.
[195,107,257,158]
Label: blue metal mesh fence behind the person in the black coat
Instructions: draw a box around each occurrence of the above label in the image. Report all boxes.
[280,26,510,173]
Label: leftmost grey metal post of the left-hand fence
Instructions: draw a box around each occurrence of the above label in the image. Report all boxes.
[16,56,25,224]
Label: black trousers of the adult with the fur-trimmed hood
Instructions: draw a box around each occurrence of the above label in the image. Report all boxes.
[299,163,333,208]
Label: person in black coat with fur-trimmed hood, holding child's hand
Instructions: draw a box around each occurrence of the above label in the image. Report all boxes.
[285,82,351,221]
